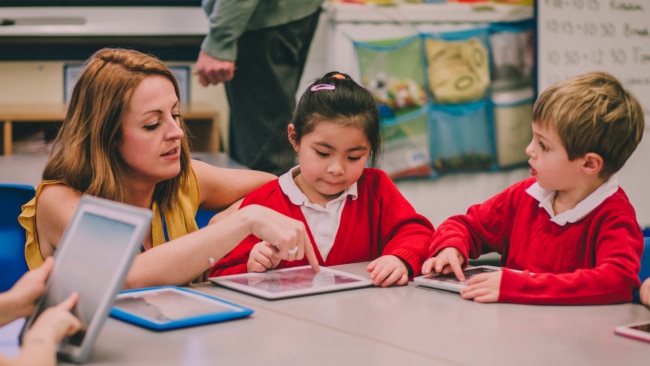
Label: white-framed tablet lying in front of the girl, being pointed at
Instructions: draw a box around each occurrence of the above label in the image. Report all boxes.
[209,266,372,300]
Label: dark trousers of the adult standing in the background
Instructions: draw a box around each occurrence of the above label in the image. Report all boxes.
[225,9,320,175]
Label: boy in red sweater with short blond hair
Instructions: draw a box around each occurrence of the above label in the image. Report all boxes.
[422,72,644,304]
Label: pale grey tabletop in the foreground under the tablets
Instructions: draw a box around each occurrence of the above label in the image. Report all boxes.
[52,263,650,366]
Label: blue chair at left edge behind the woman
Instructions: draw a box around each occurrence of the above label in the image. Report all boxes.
[0,183,35,292]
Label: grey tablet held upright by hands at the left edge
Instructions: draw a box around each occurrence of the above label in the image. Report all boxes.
[20,195,151,363]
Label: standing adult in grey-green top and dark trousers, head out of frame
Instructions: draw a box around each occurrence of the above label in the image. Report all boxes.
[196,0,324,175]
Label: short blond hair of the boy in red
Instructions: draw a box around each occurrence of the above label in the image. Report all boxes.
[533,71,645,179]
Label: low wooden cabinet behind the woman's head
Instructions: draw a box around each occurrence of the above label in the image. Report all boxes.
[0,103,221,155]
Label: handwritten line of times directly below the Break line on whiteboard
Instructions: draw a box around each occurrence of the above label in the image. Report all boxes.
[544,46,650,67]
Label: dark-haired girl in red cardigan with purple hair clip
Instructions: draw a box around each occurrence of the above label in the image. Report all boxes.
[212,72,433,287]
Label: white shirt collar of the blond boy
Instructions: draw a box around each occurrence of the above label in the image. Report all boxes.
[526,175,618,226]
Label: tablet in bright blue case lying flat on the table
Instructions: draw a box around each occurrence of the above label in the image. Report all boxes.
[111,286,253,330]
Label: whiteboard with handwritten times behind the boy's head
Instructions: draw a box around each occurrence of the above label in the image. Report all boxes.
[535,0,650,227]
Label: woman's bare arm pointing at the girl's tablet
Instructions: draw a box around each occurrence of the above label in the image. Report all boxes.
[36,185,318,288]
